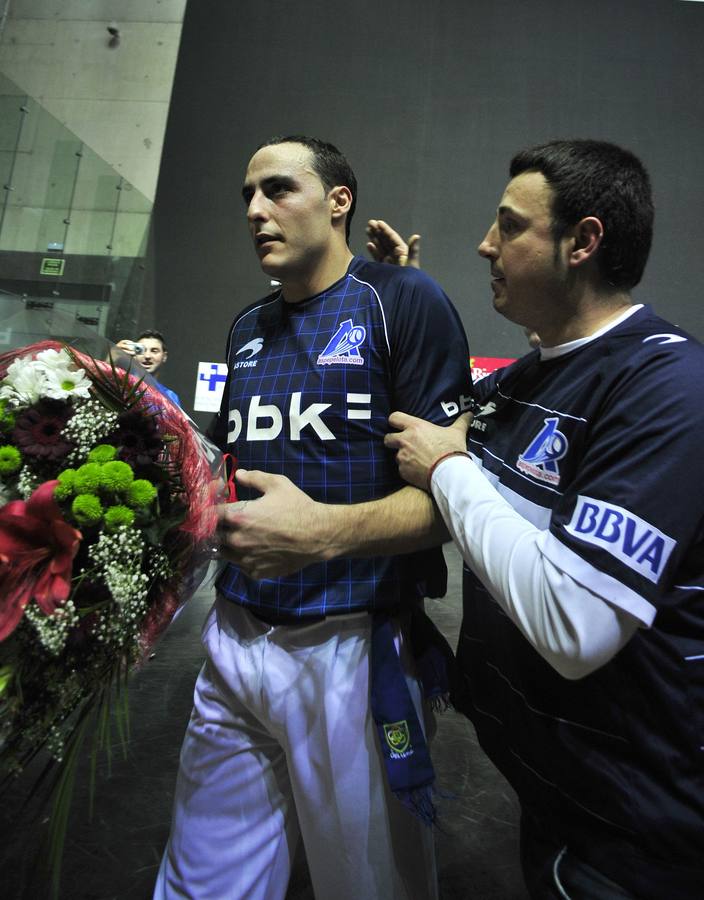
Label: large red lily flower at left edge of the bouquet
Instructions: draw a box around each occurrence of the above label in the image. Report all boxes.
[0,481,83,641]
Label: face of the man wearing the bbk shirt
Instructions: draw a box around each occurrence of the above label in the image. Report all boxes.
[242,143,334,285]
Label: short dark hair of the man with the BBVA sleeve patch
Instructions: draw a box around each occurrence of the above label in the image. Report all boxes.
[510,140,654,290]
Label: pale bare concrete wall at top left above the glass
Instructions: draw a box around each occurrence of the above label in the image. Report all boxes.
[0,0,186,201]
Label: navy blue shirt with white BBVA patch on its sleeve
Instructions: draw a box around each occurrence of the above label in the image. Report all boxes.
[456,307,704,900]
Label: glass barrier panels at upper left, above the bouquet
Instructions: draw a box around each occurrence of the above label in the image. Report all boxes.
[0,75,152,352]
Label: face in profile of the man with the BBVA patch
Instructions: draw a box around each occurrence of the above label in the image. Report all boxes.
[478,172,569,336]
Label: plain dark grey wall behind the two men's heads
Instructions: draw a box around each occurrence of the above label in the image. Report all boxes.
[153,0,704,418]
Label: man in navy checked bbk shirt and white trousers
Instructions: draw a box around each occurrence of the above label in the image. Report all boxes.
[155,136,471,900]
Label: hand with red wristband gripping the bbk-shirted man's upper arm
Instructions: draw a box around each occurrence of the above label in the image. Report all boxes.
[384,412,473,491]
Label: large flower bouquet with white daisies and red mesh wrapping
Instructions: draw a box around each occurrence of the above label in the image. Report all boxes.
[0,341,221,892]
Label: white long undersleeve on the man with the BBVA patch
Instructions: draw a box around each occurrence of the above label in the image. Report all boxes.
[431,456,640,679]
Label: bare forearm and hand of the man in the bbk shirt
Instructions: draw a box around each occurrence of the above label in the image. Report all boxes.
[218,469,449,579]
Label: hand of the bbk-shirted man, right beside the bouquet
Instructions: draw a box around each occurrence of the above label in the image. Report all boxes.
[217,469,327,580]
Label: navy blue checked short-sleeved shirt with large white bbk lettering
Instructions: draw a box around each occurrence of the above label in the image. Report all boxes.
[216,257,472,616]
